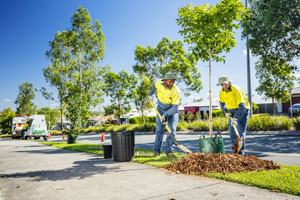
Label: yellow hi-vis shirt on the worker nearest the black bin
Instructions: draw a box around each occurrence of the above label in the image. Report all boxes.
[155,80,180,105]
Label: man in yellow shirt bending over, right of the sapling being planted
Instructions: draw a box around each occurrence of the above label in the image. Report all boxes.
[217,76,250,155]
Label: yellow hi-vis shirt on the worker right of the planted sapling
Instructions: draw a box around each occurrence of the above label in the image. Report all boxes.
[219,85,250,110]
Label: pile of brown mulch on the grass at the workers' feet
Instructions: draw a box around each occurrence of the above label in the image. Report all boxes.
[166,153,280,175]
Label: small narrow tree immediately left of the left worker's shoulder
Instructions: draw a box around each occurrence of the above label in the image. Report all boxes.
[133,77,152,124]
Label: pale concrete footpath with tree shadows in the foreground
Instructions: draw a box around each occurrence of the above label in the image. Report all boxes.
[0,139,300,200]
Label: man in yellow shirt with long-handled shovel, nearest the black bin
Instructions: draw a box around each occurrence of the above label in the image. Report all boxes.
[148,73,180,157]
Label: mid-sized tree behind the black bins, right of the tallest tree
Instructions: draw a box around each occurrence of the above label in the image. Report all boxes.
[104,70,137,123]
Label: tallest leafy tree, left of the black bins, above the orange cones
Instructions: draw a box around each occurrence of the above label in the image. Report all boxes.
[44,6,105,134]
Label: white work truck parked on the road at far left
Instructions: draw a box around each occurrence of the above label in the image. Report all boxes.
[12,115,49,140]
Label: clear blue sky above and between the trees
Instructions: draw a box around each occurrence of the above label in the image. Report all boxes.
[0,0,292,110]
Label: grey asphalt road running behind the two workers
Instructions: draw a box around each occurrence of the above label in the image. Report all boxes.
[51,134,300,166]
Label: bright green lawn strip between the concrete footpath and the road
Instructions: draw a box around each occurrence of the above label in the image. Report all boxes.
[41,142,300,196]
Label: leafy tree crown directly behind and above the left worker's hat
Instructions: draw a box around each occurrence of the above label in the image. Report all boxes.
[133,37,202,96]
